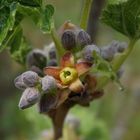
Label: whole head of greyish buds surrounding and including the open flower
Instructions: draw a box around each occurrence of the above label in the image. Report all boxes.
[15,22,127,112]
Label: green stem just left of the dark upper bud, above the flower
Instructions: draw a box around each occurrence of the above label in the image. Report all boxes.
[51,27,65,64]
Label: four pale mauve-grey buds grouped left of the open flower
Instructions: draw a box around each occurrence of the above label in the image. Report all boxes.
[14,71,57,109]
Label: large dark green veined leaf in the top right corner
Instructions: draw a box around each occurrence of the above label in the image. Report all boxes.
[101,0,140,39]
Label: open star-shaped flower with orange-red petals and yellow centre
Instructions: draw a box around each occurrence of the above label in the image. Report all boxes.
[44,52,92,93]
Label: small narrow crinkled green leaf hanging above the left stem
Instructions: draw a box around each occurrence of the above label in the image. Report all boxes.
[40,5,54,33]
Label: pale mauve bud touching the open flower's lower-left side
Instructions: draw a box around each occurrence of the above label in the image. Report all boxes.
[41,76,57,93]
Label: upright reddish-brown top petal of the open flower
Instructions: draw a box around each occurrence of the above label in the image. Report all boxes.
[61,52,74,67]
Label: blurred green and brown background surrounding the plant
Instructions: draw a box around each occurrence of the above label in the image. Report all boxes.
[0,0,140,140]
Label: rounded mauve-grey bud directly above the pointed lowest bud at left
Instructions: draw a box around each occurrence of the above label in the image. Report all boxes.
[21,71,39,87]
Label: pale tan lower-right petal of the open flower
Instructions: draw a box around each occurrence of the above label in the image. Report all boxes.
[69,78,84,93]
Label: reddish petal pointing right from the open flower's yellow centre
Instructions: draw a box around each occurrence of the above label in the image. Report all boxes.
[75,62,92,76]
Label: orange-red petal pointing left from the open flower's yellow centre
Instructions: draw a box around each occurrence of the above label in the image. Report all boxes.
[43,67,61,80]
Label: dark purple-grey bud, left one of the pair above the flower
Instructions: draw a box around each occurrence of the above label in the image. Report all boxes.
[61,30,76,50]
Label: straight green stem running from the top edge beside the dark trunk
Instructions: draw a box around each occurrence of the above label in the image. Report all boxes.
[80,0,92,30]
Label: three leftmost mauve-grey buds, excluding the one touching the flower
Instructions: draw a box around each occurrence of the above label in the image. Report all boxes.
[14,71,40,109]
